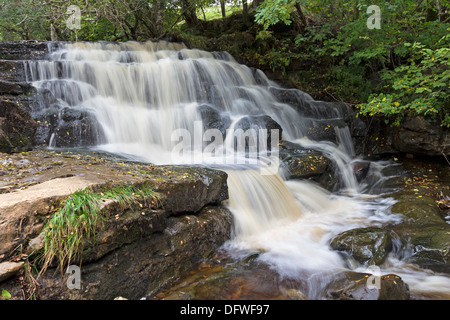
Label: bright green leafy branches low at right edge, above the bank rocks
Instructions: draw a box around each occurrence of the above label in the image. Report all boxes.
[359,36,450,127]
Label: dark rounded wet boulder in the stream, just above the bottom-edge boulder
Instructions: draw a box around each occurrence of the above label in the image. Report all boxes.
[330,227,392,265]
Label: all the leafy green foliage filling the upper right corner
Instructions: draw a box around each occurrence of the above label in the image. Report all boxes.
[256,0,450,126]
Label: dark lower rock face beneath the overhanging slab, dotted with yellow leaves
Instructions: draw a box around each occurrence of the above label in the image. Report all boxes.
[35,207,231,300]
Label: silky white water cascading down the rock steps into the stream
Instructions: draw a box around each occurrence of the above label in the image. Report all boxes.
[27,42,450,298]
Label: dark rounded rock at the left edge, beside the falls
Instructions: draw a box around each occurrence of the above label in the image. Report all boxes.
[0,100,37,153]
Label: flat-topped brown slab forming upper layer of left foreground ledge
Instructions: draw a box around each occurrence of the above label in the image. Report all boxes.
[0,150,228,262]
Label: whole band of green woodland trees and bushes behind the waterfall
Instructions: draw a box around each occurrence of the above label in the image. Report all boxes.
[0,0,450,127]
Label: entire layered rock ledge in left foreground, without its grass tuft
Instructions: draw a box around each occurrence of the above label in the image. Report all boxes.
[0,150,231,299]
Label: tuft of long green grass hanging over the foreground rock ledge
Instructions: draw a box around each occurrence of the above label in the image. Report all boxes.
[41,185,157,273]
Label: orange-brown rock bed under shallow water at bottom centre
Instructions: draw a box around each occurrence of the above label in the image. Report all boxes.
[153,251,307,300]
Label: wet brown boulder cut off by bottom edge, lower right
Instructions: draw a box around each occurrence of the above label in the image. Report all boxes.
[326,271,410,300]
